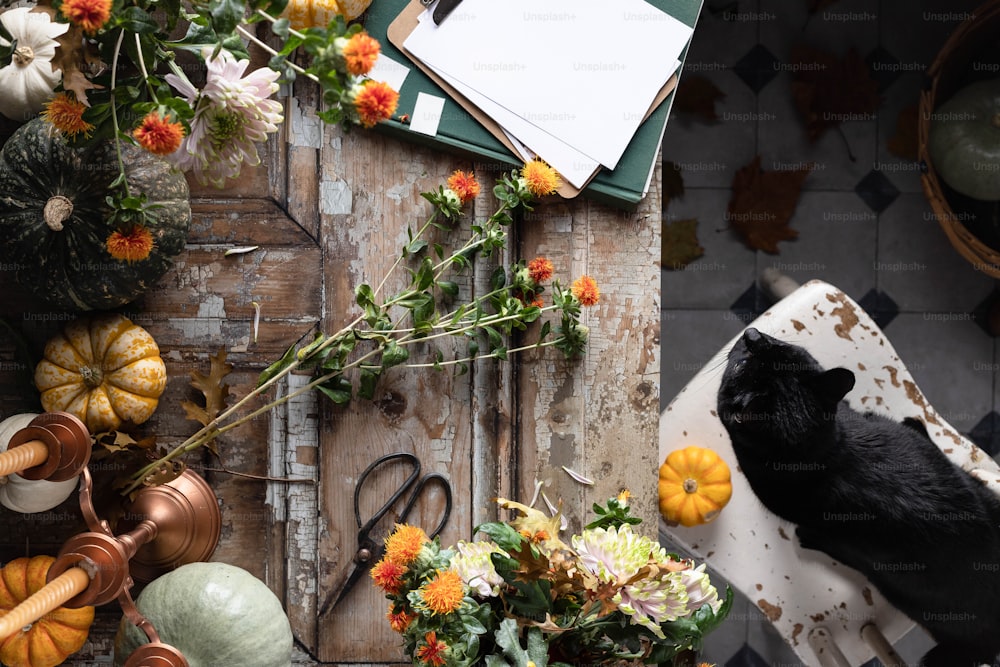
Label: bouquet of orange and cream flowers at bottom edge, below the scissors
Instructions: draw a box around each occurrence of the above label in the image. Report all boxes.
[371,491,732,667]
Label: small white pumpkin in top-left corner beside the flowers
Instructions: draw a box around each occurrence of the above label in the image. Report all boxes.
[0,7,69,122]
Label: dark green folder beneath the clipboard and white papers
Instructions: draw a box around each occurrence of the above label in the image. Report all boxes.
[365,0,702,210]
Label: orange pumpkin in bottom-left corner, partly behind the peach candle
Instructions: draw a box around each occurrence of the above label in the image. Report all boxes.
[0,556,94,667]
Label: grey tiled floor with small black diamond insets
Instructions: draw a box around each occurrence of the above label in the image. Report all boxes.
[661,0,1000,667]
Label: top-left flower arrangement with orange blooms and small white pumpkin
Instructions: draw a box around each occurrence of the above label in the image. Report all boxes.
[0,0,399,230]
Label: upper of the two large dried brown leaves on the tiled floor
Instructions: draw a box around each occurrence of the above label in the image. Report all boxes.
[790,45,879,141]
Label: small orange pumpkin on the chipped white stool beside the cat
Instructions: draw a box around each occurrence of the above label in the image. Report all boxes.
[659,445,733,526]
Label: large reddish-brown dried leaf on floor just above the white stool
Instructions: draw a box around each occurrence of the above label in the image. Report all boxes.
[727,155,812,254]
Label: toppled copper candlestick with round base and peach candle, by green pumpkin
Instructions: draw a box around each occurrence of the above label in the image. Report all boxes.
[0,460,222,667]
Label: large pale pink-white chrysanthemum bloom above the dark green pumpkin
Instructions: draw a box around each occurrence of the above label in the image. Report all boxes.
[164,48,284,188]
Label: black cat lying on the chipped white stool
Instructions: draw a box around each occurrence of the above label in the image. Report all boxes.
[718,328,1000,667]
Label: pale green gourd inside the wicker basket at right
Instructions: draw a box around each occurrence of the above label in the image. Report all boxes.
[927,79,1000,201]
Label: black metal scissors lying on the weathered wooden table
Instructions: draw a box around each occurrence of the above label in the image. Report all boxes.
[320,452,451,616]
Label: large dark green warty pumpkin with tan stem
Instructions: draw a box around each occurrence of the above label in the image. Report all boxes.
[0,118,191,311]
